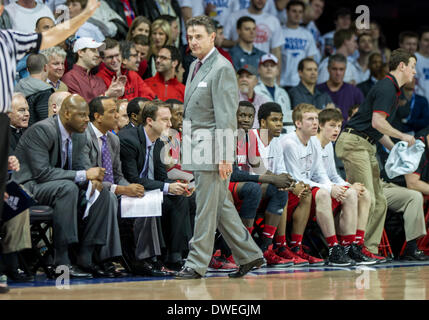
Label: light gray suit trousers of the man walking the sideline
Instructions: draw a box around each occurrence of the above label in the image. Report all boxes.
[185,171,263,275]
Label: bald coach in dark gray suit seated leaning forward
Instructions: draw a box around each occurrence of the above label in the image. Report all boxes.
[14,95,118,277]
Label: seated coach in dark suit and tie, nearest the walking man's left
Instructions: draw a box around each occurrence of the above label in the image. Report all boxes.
[119,100,191,269]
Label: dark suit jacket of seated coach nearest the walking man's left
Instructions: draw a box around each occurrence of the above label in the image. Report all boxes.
[118,126,173,191]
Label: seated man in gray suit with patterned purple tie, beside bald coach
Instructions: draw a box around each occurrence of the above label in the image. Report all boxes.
[82,96,144,276]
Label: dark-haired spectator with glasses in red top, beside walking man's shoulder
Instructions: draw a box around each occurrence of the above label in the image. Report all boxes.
[146,46,185,101]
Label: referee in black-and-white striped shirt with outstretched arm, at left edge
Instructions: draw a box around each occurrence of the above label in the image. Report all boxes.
[0,0,100,293]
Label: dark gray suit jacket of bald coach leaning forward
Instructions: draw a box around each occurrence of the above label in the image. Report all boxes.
[13,116,86,192]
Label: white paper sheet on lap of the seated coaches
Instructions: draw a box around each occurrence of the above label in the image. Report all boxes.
[121,190,164,218]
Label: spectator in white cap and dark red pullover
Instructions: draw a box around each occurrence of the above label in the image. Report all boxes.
[61,37,124,102]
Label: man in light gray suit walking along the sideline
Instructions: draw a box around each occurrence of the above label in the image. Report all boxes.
[177,16,264,279]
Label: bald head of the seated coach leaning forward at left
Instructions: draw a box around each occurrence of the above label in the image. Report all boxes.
[59,94,89,133]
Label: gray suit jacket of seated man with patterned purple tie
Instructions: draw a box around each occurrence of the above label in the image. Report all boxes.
[82,125,129,189]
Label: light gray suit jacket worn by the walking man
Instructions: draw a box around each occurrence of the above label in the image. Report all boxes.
[181,49,238,171]
